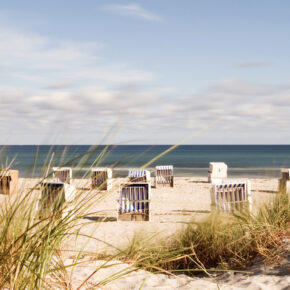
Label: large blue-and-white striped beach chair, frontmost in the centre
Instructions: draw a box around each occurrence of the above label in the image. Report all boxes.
[118,182,151,221]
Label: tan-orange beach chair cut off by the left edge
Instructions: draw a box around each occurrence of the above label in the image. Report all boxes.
[0,169,19,194]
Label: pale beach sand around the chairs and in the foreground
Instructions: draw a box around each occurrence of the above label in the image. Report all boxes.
[0,177,290,289]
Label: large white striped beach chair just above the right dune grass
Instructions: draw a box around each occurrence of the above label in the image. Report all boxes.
[211,180,252,213]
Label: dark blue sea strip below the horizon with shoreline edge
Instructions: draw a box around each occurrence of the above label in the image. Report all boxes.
[0,145,290,178]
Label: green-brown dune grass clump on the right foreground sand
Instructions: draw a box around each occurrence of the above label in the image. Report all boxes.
[122,194,290,275]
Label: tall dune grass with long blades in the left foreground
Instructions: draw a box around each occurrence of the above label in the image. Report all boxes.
[0,146,124,289]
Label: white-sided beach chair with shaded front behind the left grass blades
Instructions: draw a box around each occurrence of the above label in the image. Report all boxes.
[38,181,75,217]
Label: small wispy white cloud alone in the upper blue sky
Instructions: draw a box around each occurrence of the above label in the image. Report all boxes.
[104,3,161,21]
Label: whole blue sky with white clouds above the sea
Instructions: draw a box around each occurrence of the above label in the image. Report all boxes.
[0,0,290,144]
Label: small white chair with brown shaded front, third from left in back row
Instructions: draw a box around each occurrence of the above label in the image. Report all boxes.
[91,167,113,190]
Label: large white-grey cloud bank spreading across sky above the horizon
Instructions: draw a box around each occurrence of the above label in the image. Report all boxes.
[0,24,290,144]
